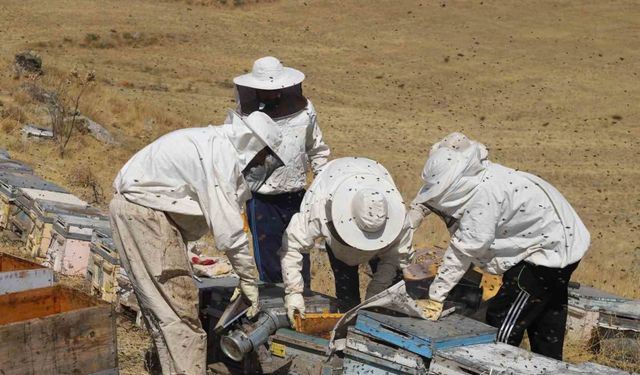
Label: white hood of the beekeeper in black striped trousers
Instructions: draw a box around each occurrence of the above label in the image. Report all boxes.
[413,133,489,213]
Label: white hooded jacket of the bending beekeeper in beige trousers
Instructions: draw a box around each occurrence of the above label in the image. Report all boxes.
[114,113,281,308]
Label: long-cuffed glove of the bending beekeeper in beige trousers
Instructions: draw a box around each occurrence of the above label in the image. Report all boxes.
[226,246,260,318]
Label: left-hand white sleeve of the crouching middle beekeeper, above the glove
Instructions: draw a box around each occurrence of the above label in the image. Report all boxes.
[279,212,322,294]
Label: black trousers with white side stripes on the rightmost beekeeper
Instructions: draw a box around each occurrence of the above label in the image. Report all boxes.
[487,261,579,360]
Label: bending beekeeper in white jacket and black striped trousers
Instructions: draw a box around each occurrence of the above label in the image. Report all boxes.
[408,133,590,359]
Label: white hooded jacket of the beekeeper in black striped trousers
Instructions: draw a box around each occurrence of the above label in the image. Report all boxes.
[414,133,590,302]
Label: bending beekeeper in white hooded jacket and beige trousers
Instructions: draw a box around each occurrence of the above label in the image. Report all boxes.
[110,112,281,374]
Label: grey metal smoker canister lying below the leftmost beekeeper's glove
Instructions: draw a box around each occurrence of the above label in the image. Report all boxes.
[220,309,289,361]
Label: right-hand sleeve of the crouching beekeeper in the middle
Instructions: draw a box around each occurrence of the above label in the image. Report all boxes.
[366,229,413,298]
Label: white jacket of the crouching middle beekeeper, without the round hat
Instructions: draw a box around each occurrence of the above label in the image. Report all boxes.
[281,158,413,320]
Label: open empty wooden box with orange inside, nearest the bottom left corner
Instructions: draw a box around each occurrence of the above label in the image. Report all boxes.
[0,286,118,375]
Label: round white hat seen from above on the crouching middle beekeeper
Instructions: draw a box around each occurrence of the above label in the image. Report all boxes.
[331,174,405,251]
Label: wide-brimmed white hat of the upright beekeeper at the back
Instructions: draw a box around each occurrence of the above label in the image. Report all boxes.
[233,56,304,90]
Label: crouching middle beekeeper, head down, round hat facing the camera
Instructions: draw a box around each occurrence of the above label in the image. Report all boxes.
[280,157,413,324]
